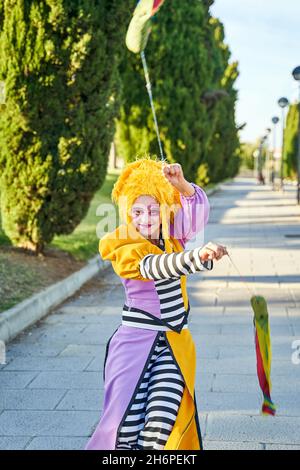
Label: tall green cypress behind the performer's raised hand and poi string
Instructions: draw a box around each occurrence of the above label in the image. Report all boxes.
[116,0,239,183]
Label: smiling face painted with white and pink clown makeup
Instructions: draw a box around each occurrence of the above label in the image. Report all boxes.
[131,195,161,239]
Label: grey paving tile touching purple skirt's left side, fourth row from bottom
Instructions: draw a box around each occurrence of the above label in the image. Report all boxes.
[27,371,102,389]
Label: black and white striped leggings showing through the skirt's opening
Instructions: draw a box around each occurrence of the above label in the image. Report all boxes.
[116,333,184,450]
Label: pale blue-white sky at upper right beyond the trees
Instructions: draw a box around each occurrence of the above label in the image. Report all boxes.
[211,0,300,141]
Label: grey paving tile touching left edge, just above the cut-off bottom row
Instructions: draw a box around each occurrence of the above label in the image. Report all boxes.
[0,410,98,437]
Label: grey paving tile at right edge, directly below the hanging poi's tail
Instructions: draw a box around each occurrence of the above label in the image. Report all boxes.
[204,411,300,445]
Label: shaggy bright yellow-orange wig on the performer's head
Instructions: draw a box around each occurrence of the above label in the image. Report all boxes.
[111,155,181,253]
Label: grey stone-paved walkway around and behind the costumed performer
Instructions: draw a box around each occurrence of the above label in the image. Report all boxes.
[0,177,300,449]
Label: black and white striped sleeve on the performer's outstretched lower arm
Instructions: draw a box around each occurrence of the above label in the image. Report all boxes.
[139,247,213,280]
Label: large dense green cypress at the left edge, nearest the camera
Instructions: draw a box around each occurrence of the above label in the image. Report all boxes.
[0,0,129,251]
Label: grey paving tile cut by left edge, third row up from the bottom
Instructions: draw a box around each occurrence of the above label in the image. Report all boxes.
[0,388,66,410]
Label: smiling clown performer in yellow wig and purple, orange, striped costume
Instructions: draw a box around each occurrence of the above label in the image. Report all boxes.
[85,155,227,450]
